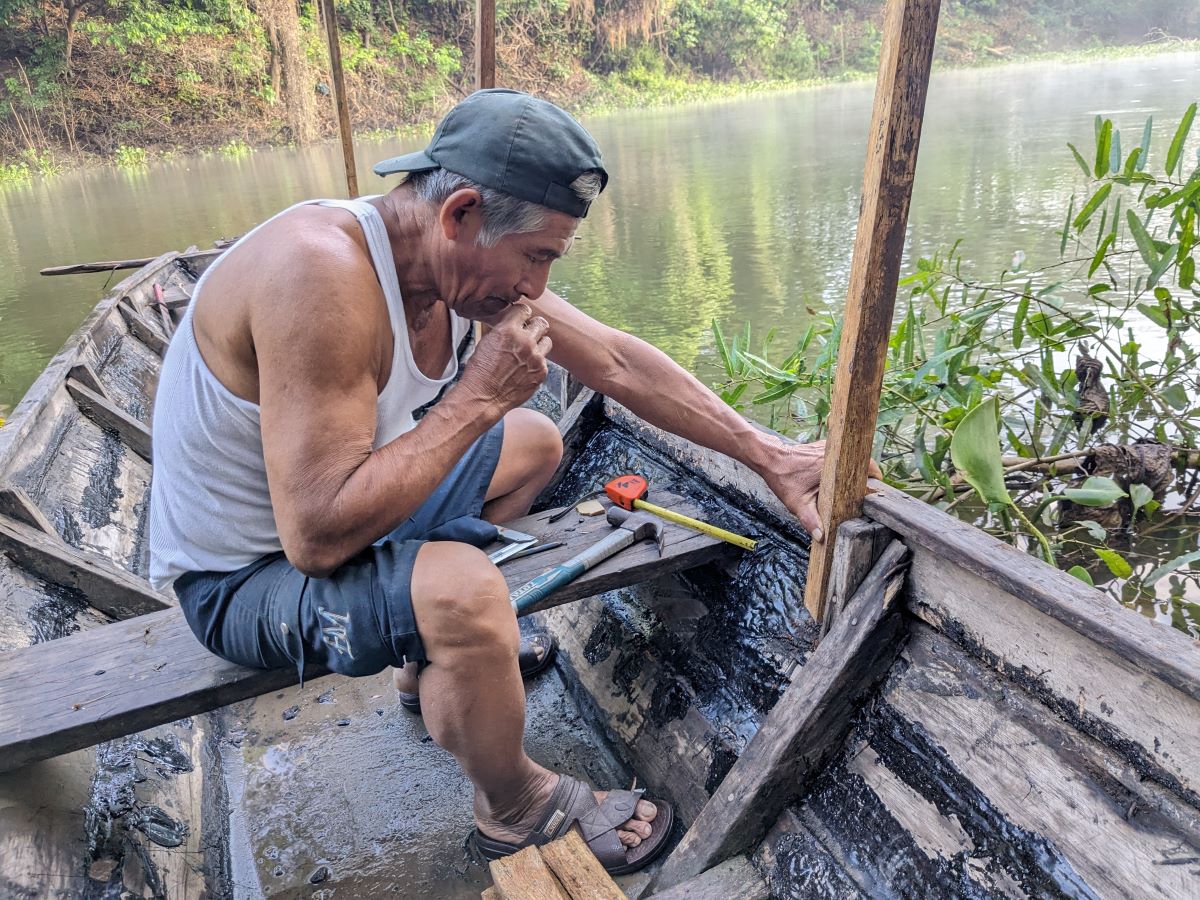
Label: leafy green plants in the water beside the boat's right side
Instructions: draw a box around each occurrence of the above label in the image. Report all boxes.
[713,103,1200,634]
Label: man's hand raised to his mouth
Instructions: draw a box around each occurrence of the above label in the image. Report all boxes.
[460,302,552,415]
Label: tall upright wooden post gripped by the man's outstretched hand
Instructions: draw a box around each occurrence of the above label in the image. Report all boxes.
[804,0,940,622]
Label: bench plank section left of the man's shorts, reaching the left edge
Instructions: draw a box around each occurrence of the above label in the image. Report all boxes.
[0,607,309,772]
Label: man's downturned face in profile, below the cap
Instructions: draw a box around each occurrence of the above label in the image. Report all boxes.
[438,195,580,323]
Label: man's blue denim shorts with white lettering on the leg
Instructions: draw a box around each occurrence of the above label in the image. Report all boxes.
[175,420,504,678]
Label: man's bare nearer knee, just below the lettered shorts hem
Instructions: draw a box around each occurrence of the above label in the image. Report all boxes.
[412,541,520,653]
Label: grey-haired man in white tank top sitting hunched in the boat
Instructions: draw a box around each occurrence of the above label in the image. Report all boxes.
[150,90,844,874]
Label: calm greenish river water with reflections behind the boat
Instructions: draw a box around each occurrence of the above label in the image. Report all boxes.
[0,54,1200,629]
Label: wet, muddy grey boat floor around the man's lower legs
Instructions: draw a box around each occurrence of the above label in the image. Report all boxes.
[221,643,647,898]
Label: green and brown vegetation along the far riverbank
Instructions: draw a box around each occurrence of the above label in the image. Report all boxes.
[0,0,1200,174]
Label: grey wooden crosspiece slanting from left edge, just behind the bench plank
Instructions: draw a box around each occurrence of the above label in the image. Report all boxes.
[0,518,172,619]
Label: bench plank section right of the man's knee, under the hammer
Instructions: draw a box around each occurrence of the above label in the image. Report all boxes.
[500,494,740,612]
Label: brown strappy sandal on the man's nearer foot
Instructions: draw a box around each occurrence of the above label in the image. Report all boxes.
[469,775,674,875]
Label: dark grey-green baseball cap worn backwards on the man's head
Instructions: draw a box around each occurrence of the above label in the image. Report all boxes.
[374,89,608,218]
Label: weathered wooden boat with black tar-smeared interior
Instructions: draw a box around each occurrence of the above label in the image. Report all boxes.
[0,236,1200,898]
